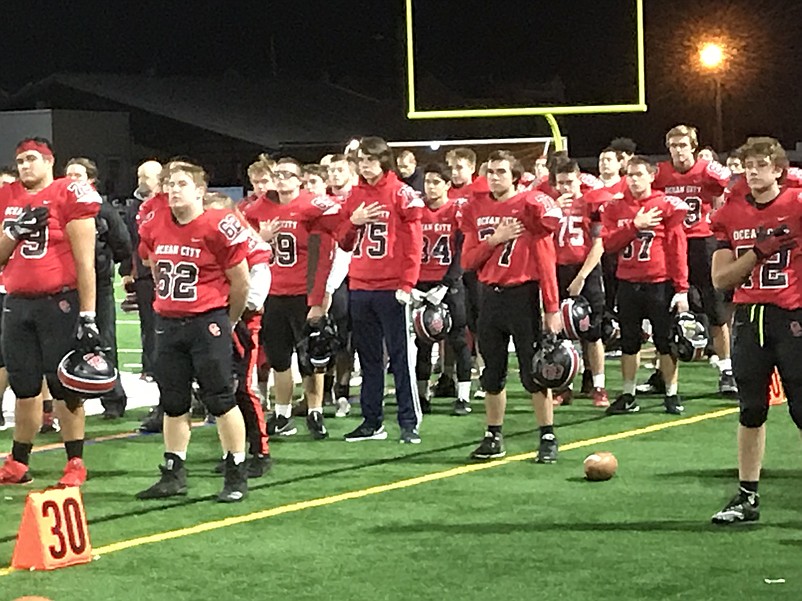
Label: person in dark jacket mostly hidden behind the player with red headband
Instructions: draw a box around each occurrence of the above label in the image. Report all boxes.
[65,157,131,419]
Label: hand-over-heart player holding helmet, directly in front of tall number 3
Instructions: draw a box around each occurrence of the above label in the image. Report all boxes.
[602,156,688,415]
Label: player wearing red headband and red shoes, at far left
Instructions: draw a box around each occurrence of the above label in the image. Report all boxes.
[0,138,101,486]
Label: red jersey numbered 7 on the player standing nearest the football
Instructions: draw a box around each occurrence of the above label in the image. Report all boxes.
[462,192,561,313]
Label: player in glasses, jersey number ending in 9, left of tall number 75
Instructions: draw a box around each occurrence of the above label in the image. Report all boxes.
[239,157,340,440]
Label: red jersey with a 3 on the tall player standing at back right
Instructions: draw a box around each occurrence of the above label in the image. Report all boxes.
[652,160,731,238]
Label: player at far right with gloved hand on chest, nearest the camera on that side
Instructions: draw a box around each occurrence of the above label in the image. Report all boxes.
[712,137,802,524]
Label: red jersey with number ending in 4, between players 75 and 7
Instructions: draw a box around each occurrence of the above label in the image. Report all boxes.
[419,199,460,282]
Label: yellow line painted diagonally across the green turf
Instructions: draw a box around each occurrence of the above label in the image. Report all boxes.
[0,408,738,577]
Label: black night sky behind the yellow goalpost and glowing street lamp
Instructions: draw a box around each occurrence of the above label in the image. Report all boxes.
[0,0,802,153]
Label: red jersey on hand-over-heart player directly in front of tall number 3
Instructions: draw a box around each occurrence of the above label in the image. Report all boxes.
[601,190,688,292]
